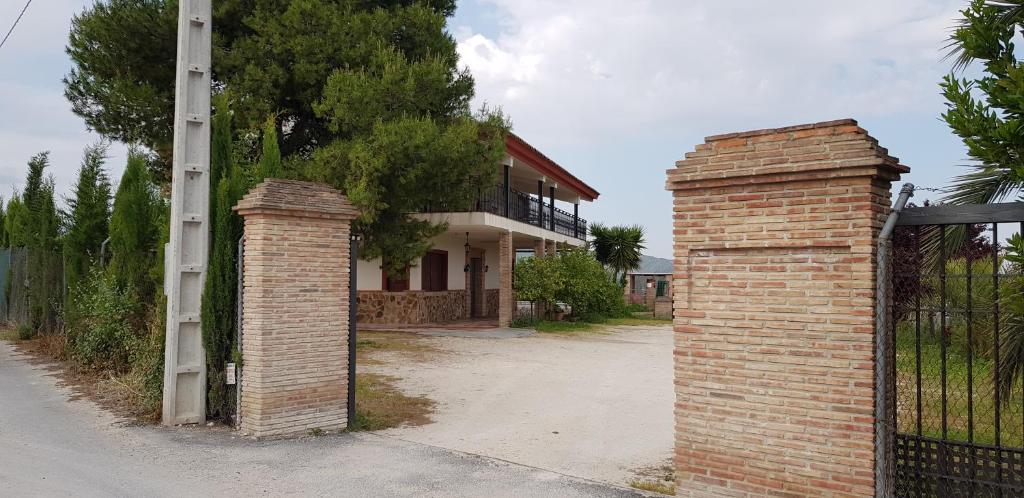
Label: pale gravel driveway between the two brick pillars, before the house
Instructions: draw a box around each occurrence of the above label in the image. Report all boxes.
[360,326,675,485]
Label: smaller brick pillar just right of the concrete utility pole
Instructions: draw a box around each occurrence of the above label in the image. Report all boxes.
[234,179,355,438]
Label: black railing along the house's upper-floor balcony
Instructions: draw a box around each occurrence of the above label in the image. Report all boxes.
[424,185,587,240]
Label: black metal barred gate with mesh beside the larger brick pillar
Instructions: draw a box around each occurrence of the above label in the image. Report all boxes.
[888,203,1024,497]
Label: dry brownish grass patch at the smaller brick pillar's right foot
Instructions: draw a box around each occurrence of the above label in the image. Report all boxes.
[348,373,434,432]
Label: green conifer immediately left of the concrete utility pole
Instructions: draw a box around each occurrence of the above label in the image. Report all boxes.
[109,151,161,302]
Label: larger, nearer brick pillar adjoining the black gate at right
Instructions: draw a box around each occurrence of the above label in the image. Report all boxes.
[667,120,909,496]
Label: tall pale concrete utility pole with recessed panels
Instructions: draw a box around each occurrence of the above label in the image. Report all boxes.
[163,0,213,425]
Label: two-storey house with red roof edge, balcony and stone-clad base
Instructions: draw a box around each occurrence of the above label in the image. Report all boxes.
[356,133,599,326]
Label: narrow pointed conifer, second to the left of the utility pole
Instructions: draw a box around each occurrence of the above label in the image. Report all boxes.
[63,143,111,288]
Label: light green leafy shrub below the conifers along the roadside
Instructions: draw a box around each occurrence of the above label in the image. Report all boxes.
[66,268,140,372]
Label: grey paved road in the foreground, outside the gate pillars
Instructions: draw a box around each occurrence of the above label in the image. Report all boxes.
[0,341,635,497]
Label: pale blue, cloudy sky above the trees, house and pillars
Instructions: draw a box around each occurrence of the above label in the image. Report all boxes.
[0,0,983,257]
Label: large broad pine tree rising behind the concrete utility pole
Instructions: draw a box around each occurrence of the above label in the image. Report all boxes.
[65,0,509,269]
